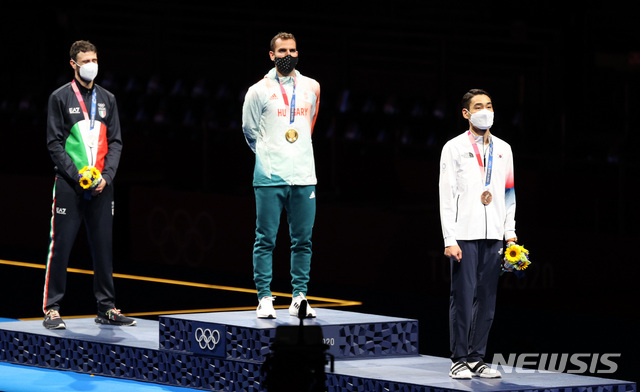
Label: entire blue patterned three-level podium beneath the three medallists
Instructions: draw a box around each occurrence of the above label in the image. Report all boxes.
[0,308,636,392]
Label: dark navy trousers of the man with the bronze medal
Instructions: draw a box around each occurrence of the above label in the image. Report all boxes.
[449,240,502,362]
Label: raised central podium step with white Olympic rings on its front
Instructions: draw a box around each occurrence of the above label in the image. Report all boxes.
[159,309,418,362]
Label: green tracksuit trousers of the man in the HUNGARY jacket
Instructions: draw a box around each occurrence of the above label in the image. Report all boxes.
[253,185,316,299]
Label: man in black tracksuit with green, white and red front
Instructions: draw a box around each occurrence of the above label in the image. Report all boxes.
[43,41,136,329]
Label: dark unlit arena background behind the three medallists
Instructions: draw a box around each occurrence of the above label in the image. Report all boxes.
[0,1,640,381]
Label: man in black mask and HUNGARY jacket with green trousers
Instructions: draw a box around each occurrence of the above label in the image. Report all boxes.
[242,33,320,318]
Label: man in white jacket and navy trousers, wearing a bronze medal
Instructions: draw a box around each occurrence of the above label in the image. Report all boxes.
[439,89,516,379]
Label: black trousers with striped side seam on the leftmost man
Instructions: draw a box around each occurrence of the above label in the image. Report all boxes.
[43,177,115,312]
